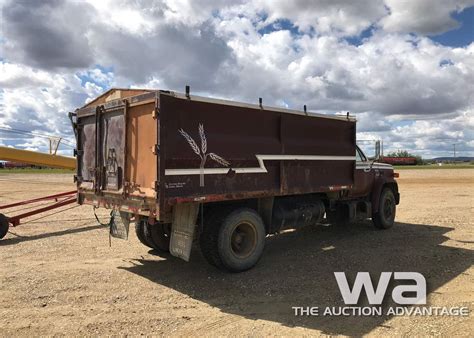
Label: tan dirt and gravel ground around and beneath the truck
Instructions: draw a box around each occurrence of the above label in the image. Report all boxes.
[0,169,474,336]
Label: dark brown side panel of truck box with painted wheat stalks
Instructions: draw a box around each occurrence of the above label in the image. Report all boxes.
[160,94,355,209]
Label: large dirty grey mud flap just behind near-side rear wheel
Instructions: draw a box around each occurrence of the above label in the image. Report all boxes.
[170,203,199,262]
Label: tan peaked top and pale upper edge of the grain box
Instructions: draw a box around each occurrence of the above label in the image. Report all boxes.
[77,88,356,121]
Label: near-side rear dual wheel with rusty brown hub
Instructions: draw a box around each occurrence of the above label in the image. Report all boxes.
[199,208,266,272]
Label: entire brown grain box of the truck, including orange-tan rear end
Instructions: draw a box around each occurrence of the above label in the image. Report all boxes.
[77,89,355,220]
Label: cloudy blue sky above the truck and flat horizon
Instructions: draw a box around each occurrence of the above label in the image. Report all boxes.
[0,0,474,158]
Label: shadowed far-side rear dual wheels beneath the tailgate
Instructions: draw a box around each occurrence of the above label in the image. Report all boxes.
[135,218,171,252]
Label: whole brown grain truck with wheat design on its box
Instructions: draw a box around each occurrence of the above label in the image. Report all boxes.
[73,89,399,271]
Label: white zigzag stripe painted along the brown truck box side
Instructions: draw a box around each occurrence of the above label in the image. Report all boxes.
[165,155,355,176]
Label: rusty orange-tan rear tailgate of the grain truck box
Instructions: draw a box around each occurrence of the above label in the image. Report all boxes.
[77,95,158,213]
